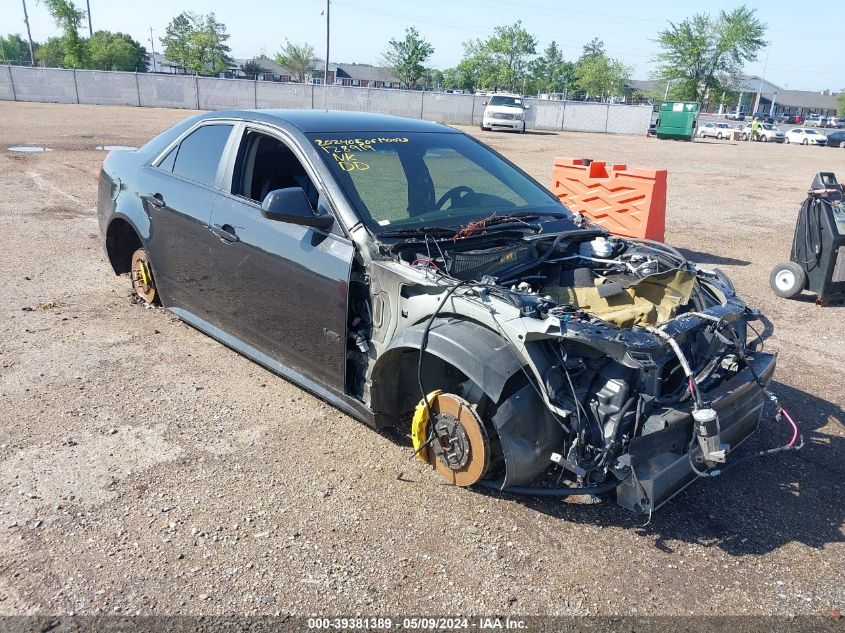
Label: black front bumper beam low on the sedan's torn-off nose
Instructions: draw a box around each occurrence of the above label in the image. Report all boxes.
[616,353,776,514]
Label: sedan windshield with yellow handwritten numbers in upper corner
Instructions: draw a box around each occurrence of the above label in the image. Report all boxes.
[308,132,570,234]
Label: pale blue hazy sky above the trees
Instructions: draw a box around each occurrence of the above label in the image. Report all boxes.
[8,0,845,91]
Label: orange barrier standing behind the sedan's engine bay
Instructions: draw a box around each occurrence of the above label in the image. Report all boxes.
[552,158,666,242]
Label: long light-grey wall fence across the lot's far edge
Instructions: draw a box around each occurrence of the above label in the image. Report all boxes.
[0,66,651,134]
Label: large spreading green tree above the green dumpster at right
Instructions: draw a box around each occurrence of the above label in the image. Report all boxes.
[656,5,766,101]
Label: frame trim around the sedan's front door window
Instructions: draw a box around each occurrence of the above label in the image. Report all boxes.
[219,120,352,243]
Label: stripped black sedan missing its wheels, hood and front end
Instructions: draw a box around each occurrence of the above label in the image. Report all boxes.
[98,110,797,513]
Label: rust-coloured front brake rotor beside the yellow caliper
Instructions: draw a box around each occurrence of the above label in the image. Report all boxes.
[425,393,490,486]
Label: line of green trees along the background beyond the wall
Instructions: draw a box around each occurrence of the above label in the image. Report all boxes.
[0,0,767,107]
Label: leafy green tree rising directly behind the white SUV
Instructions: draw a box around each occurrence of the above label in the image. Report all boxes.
[458,22,537,91]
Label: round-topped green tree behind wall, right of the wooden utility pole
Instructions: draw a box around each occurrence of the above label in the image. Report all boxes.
[161,11,232,74]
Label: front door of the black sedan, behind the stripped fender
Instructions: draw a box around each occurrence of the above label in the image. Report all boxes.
[211,126,354,393]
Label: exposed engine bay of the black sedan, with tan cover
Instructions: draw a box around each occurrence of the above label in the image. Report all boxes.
[382,230,792,510]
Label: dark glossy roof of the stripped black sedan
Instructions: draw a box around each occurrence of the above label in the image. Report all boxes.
[203,109,461,134]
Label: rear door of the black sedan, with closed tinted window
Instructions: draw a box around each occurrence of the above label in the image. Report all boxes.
[142,122,236,320]
